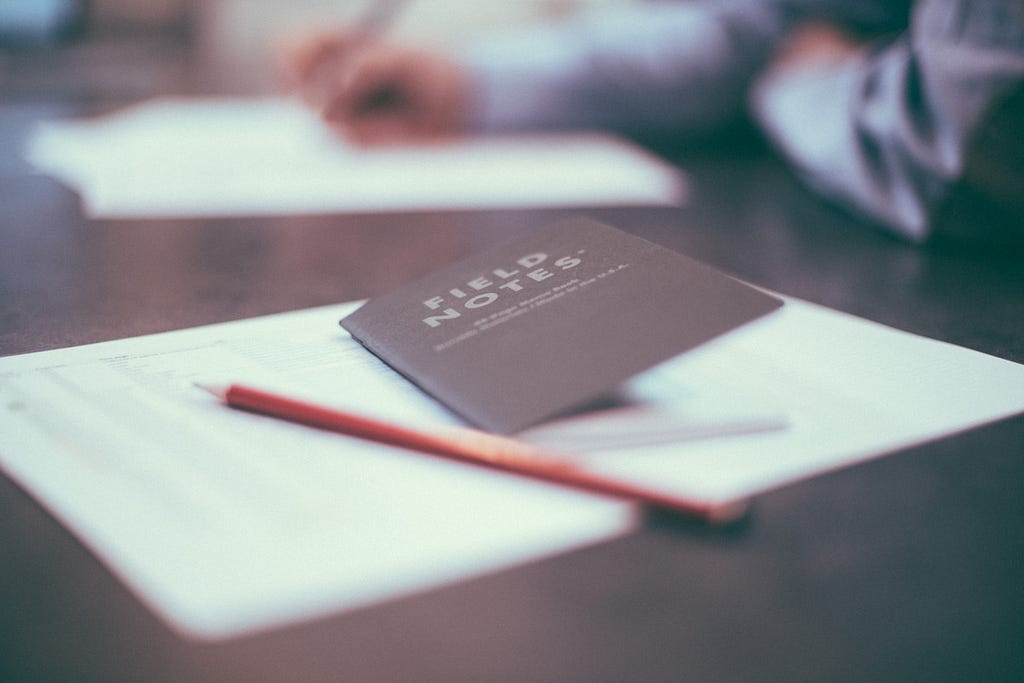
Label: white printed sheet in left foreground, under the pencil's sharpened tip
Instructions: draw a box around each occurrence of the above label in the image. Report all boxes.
[0,307,633,638]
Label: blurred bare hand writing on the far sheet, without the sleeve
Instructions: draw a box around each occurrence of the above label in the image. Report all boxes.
[281,34,468,144]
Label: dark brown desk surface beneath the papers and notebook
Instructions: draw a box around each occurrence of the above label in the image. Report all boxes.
[0,30,1024,681]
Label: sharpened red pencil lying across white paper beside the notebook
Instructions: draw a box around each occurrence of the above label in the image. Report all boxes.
[196,383,746,523]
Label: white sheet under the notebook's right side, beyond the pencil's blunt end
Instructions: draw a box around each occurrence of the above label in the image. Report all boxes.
[577,300,1024,501]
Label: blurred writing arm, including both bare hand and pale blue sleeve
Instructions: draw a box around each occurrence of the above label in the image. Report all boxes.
[283,0,790,143]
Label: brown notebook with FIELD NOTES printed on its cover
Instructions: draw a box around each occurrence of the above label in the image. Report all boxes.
[341,219,782,433]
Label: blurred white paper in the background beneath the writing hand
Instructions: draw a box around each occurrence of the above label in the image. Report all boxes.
[26,98,686,218]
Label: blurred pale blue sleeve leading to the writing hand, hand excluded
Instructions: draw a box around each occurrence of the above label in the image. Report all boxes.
[458,0,786,135]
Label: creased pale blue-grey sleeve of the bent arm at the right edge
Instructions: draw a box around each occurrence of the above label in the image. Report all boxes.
[753,0,1024,242]
